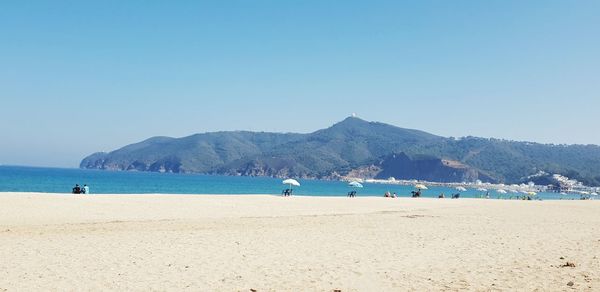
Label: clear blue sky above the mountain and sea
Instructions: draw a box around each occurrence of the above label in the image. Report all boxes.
[0,0,600,167]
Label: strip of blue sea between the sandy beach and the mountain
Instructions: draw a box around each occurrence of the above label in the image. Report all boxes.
[0,166,579,200]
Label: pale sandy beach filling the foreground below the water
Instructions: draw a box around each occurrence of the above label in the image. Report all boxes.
[0,193,600,291]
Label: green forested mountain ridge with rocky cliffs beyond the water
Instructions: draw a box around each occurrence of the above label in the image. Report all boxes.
[80,117,600,185]
